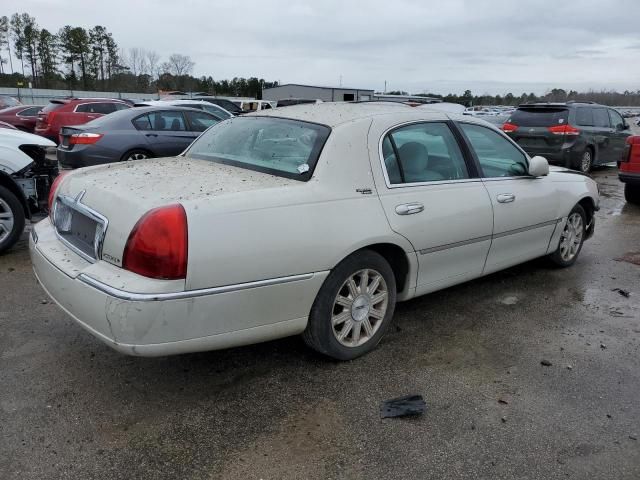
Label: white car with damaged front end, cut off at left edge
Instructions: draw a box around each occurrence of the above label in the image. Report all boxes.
[0,128,58,253]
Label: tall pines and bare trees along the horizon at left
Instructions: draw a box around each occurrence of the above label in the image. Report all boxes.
[0,13,277,97]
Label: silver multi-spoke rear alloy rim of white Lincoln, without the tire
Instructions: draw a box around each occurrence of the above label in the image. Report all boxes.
[331,269,389,347]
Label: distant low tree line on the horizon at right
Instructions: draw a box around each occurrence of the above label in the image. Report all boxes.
[385,88,640,107]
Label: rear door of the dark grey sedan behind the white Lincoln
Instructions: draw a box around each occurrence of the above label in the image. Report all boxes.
[143,110,194,157]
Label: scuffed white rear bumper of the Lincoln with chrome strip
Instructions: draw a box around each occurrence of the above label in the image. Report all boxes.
[29,220,328,356]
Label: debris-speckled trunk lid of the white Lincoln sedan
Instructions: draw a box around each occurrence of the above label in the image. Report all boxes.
[54,157,300,266]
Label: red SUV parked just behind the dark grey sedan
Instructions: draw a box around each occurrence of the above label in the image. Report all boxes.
[34,98,131,143]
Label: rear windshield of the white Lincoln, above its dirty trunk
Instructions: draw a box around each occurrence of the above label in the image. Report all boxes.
[185,117,330,181]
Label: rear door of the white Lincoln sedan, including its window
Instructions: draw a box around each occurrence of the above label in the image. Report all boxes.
[378,121,493,295]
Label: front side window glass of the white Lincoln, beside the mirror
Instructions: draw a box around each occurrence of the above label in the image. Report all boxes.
[459,123,529,178]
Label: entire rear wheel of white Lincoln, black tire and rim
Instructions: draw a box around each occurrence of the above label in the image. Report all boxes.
[302,250,396,360]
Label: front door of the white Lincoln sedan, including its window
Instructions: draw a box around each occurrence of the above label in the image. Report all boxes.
[458,122,559,274]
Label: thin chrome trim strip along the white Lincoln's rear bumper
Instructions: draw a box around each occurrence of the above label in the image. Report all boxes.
[78,272,328,302]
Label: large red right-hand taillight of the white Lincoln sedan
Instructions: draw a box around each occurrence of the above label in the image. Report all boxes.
[122,204,189,280]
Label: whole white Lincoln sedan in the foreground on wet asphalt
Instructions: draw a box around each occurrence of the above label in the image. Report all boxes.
[30,103,598,360]
